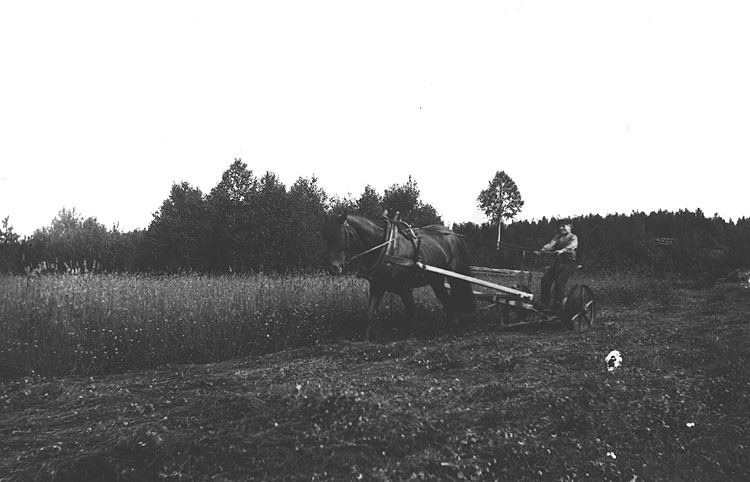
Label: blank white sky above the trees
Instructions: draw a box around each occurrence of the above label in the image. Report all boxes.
[0,0,750,235]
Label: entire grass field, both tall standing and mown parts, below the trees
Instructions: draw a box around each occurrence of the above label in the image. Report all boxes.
[0,274,750,481]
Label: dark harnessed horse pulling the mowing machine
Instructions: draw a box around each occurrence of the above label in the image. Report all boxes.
[323,213,474,340]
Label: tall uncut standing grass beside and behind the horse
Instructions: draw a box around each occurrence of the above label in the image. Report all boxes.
[0,275,664,379]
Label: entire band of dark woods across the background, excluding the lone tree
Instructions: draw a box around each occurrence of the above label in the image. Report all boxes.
[0,159,750,278]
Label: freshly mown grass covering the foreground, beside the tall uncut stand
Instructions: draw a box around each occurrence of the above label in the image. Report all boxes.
[0,280,750,481]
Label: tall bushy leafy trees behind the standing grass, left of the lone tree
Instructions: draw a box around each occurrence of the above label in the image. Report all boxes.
[0,159,442,273]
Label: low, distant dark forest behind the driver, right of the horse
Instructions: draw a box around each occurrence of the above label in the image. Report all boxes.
[453,209,750,279]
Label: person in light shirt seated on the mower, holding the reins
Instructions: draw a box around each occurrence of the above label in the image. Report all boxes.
[537,219,578,309]
